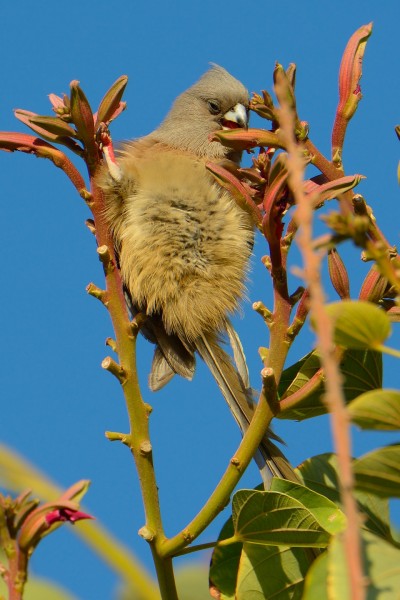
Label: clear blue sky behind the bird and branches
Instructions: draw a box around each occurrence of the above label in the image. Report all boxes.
[0,0,400,600]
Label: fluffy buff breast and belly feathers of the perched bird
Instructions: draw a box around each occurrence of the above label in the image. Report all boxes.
[111,152,253,339]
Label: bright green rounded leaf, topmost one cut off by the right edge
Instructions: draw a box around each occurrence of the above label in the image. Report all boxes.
[348,389,400,430]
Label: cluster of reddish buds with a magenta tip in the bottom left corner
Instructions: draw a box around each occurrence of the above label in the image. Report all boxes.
[0,480,93,598]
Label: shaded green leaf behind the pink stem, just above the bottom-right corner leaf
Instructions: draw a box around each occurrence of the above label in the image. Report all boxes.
[296,453,393,542]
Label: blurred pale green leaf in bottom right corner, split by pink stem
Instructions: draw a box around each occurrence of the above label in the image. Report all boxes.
[303,531,400,600]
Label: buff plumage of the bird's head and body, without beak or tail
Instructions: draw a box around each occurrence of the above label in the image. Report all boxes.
[100,67,253,346]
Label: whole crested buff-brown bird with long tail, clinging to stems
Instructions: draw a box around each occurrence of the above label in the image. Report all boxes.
[97,64,295,481]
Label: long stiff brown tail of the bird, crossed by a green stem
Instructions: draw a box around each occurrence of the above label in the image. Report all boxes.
[196,324,299,486]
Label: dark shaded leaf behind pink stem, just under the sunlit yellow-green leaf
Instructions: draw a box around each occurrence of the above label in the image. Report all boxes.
[277,350,382,421]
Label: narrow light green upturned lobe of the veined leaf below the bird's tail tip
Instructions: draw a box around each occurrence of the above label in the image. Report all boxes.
[271,477,346,534]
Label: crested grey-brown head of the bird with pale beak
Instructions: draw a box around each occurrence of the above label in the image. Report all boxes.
[152,65,249,161]
